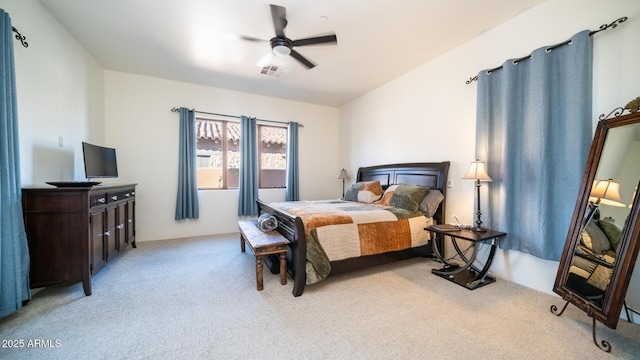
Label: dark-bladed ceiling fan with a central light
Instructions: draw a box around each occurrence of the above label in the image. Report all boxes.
[240,5,338,69]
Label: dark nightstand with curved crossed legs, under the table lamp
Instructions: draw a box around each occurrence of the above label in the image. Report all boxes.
[425,226,507,290]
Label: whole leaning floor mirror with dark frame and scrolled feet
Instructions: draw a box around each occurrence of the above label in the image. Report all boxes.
[551,97,640,352]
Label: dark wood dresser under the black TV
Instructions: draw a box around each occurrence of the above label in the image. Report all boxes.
[22,184,136,296]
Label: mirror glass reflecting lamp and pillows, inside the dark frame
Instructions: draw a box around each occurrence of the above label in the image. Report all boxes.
[566,124,640,308]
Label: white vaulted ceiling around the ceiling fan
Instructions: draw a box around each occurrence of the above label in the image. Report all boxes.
[40,0,543,107]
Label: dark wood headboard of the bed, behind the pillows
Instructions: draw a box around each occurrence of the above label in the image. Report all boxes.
[356,161,450,224]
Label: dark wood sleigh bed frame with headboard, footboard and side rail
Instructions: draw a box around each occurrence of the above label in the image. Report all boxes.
[257,161,450,296]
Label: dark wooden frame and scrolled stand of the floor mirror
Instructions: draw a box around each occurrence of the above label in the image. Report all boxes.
[551,97,640,351]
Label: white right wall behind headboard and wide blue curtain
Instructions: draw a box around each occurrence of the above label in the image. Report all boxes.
[340,0,640,293]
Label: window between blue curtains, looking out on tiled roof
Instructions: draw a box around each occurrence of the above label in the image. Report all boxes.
[196,119,287,189]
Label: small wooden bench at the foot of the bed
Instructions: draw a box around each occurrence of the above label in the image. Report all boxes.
[238,220,289,291]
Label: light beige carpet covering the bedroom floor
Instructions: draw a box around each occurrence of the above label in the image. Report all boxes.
[0,234,640,359]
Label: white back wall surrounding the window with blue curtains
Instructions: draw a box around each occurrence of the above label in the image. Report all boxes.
[105,71,342,241]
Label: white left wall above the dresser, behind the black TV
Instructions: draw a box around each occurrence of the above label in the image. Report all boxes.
[0,0,104,185]
